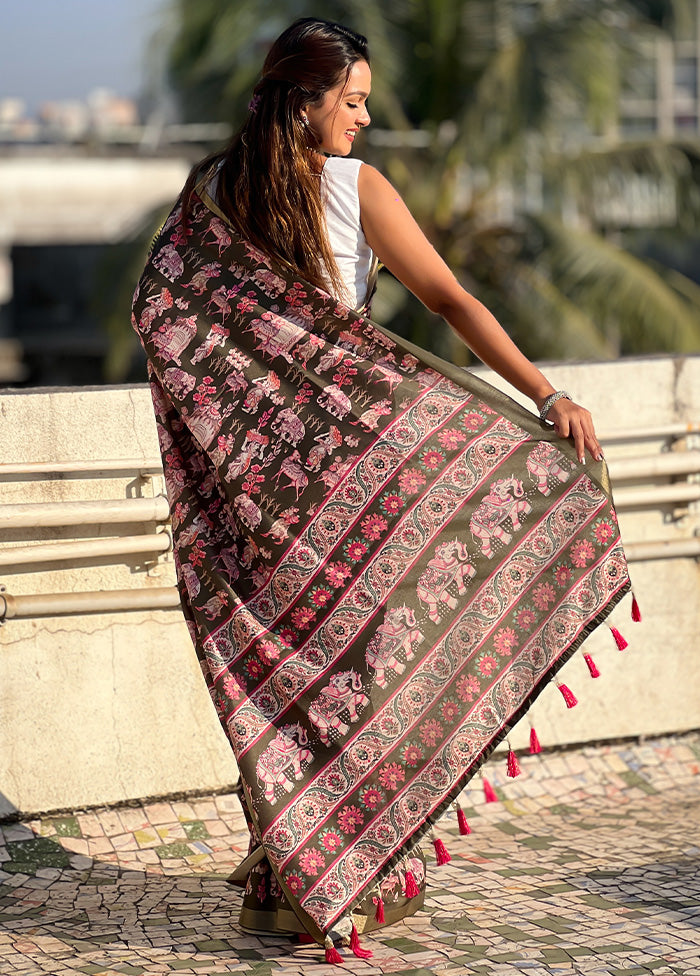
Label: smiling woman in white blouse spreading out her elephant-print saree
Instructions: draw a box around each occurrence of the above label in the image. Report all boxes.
[134,19,629,961]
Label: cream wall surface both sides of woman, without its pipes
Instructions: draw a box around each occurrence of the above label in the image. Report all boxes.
[0,357,700,813]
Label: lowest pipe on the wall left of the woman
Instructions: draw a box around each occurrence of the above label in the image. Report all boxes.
[0,586,180,622]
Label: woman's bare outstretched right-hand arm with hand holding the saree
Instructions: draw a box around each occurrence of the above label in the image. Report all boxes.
[358,165,602,462]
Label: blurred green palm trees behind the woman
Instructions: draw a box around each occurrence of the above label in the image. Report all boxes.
[142,0,700,363]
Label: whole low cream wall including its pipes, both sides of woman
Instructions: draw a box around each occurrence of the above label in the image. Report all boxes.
[0,357,700,815]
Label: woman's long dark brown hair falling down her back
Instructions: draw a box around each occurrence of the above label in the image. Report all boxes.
[182,17,369,292]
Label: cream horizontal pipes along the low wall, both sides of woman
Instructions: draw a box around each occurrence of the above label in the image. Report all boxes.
[0,423,700,622]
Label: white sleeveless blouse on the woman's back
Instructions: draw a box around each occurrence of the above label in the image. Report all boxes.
[321,156,374,308]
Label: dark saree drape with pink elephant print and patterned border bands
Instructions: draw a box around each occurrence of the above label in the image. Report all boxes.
[133,192,629,945]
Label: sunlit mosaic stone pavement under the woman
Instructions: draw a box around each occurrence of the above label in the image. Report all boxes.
[0,734,700,976]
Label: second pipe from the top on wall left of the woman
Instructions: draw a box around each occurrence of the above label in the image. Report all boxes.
[0,495,170,529]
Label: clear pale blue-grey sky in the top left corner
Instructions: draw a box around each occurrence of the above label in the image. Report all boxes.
[0,0,167,114]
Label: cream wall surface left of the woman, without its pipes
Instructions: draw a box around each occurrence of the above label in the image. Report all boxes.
[0,386,237,811]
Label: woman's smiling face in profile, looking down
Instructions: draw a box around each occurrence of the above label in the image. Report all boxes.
[303,61,372,156]
